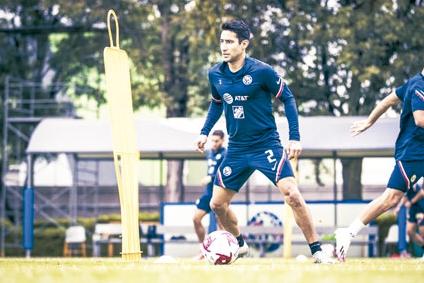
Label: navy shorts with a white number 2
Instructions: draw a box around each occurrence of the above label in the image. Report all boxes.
[215,146,294,192]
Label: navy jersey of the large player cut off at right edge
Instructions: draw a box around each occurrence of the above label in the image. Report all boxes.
[395,73,424,161]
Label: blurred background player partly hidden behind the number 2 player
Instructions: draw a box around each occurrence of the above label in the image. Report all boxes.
[193,130,227,260]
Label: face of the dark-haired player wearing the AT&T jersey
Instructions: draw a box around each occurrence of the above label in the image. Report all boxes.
[220,30,249,63]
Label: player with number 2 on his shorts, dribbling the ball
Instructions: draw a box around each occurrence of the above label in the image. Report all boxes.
[195,20,334,263]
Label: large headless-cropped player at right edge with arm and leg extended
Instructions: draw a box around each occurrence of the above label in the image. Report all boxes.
[336,69,424,262]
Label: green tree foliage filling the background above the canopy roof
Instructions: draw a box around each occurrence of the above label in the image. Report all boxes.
[0,0,424,116]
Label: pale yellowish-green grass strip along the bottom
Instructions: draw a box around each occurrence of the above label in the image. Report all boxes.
[0,258,424,283]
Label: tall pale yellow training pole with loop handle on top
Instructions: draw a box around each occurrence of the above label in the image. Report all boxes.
[103,10,141,261]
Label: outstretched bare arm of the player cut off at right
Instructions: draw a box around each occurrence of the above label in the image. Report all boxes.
[350,91,401,137]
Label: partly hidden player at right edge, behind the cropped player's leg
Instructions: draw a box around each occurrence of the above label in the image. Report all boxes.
[394,184,424,260]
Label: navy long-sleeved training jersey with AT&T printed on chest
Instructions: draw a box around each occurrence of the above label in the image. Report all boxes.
[201,56,300,148]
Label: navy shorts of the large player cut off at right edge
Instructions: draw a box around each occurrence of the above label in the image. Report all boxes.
[387,160,424,192]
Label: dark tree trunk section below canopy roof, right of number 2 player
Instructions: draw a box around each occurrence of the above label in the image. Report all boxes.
[340,157,362,200]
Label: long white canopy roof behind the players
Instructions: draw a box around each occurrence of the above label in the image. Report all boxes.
[27,116,399,159]
